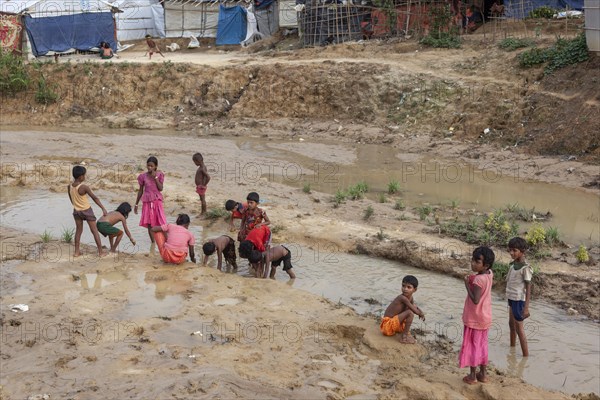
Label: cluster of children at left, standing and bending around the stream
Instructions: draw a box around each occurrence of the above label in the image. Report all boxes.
[68,153,296,279]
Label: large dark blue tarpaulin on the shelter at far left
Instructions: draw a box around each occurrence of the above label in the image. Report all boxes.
[25,12,117,57]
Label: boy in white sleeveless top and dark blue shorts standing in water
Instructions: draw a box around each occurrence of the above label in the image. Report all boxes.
[506,237,533,357]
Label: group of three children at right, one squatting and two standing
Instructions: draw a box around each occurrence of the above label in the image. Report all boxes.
[380,237,533,385]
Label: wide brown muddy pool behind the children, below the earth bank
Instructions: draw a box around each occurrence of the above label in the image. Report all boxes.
[237,139,600,245]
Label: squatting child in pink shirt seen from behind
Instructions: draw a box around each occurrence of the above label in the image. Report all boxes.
[152,214,196,264]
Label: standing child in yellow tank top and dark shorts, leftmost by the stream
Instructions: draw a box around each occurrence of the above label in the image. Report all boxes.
[67,165,107,257]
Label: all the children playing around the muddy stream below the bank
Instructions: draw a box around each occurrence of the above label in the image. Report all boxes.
[68,153,533,384]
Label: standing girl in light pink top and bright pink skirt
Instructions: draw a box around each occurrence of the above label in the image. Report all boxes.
[458,246,495,385]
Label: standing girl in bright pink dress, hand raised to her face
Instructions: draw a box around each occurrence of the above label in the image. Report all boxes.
[133,157,167,244]
